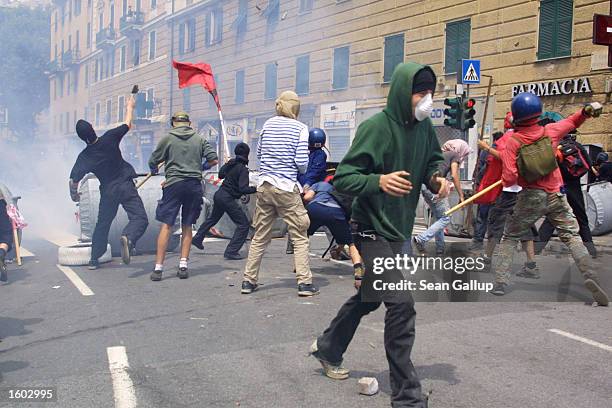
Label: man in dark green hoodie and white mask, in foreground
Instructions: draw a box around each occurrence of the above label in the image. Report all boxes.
[310,63,448,408]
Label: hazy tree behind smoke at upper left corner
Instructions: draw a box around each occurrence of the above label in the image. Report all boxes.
[0,6,50,142]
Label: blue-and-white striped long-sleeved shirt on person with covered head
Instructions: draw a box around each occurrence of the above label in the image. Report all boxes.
[257,116,308,192]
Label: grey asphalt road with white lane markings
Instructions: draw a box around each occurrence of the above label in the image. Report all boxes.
[0,231,612,408]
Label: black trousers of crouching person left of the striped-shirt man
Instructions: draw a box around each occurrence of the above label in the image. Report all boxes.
[197,188,249,256]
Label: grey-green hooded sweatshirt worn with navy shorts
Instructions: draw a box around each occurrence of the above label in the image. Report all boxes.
[149,126,217,187]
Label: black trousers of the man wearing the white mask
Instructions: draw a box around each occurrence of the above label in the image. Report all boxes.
[317,231,425,408]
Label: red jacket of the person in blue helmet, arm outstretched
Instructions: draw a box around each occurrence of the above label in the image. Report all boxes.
[500,109,587,193]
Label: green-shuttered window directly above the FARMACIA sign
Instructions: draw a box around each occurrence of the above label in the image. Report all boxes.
[538,0,574,60]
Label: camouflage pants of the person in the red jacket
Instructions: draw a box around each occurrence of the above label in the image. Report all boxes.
[493,189,595,284]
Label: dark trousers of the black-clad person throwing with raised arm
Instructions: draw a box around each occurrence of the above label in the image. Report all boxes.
[91,180,149,260]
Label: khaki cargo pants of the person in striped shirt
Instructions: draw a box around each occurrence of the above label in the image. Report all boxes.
[244,182,312,284]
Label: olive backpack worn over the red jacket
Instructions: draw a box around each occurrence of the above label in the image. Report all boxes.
[512,129,558,183]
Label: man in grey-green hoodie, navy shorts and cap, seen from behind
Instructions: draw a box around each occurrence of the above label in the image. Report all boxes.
[149,112,219,281]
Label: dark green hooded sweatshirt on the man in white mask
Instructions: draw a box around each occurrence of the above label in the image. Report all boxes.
[334,63,443,242]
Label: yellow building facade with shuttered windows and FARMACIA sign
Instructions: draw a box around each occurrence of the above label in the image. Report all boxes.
[50,0,612,171]
